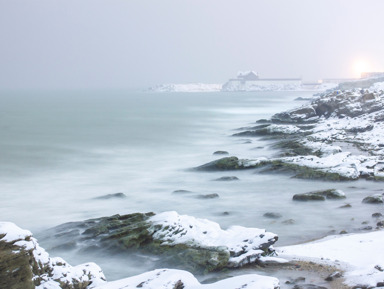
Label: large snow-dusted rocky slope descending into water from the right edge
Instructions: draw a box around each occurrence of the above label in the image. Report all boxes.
[196,84,384,181]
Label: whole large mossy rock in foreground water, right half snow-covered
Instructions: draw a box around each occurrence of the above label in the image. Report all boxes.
[39,212,278,272]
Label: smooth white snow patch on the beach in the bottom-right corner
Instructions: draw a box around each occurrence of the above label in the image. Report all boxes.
[277,231,384,288]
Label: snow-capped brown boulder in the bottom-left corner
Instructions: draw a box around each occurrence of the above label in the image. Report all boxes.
[0,222,105,289]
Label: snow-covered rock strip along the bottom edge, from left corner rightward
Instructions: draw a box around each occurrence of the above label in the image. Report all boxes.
[0,222,279,289]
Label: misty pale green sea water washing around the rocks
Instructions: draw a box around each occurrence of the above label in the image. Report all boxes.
[0,91,381,280]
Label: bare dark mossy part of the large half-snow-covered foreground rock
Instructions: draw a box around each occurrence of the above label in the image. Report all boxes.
[42,212,277,272]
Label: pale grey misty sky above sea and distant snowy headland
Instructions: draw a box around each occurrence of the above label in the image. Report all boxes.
[0,0,384,89]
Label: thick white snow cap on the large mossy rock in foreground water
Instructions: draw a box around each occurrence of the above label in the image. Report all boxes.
[149,212,277,267]
